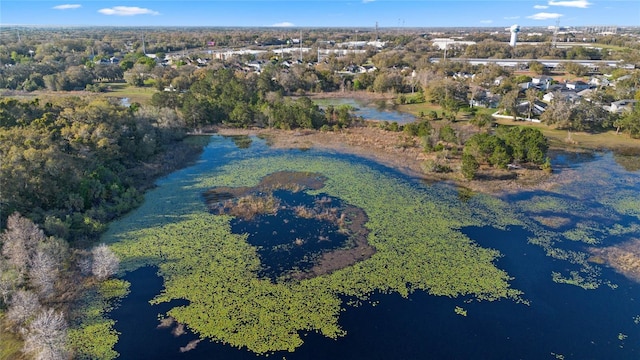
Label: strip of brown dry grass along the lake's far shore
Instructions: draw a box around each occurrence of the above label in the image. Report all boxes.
[214,127,559,195]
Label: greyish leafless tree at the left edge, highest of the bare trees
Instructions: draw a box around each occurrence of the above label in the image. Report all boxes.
[0,213,45,274]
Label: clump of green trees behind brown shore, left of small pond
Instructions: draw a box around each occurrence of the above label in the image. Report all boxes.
[151,68,360,130]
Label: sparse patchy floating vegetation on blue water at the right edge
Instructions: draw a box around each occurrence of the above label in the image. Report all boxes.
[514,168,640,289]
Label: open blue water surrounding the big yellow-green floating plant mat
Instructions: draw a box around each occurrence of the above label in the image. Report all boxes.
[105,136,640,359]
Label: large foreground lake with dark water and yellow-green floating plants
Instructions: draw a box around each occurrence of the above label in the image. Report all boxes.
[97,136,640,359]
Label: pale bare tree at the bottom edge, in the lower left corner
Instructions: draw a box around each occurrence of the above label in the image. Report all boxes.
[23,309,69,360]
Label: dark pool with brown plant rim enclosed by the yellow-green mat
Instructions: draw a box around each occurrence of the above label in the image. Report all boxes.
[205,171,375,280]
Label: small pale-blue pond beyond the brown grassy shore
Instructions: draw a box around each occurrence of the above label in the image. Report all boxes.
[313,98,416,124]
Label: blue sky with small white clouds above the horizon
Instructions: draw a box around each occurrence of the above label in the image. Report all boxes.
[0,0,640,28]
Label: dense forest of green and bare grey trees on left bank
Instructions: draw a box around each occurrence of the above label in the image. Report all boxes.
[0,97,196,359]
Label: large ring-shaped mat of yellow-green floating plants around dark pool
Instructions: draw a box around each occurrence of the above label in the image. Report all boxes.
[97,155,521,353]
